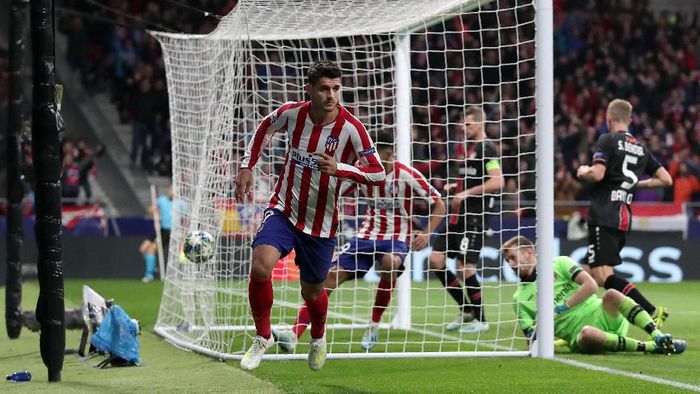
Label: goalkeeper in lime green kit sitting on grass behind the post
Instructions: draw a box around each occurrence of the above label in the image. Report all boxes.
[501,236,686,354]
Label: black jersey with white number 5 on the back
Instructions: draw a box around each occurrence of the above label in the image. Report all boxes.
[588,132,661,231]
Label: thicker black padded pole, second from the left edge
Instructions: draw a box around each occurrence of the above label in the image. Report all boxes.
[30,0,66,382]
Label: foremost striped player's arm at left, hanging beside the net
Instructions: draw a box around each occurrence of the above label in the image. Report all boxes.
[234,103,294,202]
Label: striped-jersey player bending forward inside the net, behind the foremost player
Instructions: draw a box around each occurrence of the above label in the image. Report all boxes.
[272,143,446,352]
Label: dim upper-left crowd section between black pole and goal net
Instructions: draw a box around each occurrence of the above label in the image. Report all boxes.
[58,0,235,176]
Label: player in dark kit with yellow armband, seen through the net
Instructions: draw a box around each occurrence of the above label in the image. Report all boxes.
[430,106,503,333]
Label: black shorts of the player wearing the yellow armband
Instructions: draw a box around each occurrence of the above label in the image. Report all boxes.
[431,225,484,264]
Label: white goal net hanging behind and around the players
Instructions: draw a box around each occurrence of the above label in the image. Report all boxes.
[153,0,535,359]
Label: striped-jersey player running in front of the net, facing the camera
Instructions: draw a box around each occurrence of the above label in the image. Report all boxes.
[235,60,386,370]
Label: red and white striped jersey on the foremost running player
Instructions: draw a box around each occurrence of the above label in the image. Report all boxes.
[241,101,386,238]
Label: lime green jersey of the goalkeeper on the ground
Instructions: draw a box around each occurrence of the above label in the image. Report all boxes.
[513,256,600,340]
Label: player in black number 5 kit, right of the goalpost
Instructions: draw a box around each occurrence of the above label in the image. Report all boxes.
[577,99,673,326]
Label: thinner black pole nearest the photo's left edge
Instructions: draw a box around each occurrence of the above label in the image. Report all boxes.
[5,0,29,339]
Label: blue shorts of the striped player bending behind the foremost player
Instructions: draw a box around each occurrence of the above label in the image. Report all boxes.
[336,237,408,278]
